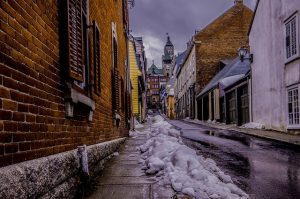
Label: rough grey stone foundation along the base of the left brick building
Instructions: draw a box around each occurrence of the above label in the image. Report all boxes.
[0,138,125,198]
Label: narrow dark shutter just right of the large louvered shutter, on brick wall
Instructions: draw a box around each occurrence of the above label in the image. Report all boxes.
[93,21,101,95]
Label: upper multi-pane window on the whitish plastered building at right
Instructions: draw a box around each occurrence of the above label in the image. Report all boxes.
[285,14,299,61]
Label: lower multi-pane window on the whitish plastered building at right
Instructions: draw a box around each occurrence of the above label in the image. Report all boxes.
[288,87,299,126]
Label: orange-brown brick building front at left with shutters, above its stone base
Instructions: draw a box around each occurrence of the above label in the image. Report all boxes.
[0,0,130,166]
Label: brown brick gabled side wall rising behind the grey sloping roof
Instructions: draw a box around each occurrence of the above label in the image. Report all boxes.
[194,0,253,120]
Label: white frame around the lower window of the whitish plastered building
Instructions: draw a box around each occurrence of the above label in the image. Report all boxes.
[286,84,300,129]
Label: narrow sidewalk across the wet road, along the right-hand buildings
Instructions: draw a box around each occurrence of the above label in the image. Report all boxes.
[184,119,300,146]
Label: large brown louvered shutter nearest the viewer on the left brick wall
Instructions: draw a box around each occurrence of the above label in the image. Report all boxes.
[67,0,84,82]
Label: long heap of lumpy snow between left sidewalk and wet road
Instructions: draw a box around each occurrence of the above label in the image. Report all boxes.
[139,116,249,199]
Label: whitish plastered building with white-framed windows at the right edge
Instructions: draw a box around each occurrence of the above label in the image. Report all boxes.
[249,0,300,132]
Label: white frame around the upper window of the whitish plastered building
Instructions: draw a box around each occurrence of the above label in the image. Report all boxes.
[283,12,300,63]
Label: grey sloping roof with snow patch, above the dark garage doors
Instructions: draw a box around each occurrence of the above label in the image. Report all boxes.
[197,57,250,97]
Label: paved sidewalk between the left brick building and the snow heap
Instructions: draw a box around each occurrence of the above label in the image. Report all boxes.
[82,125,185,199]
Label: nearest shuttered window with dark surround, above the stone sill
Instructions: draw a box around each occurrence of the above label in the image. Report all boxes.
[62,0,89,87]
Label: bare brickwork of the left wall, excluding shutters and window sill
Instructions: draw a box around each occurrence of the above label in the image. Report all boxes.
[0,0,127,166]
